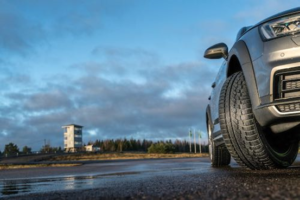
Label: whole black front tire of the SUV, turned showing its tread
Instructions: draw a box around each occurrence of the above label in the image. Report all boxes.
[219,72,299,169]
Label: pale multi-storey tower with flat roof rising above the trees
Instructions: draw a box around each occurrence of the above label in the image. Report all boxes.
[62,124,83,152]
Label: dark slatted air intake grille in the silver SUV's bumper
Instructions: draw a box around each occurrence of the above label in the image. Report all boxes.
[273,67,300,101]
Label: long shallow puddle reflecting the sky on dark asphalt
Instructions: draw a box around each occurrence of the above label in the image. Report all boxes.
[0,166,204,198]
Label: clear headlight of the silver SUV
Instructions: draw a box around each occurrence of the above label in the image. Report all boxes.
[260,14,300,39]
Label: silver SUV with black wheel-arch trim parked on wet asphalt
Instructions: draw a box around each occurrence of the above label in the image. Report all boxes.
[204,7,300,169]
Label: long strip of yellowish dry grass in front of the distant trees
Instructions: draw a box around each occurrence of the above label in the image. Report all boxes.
[49,152,208,161]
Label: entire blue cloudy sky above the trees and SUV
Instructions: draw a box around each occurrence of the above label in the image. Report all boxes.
[0,0,299,151]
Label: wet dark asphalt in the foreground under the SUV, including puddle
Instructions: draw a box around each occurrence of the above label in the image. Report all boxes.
[0,158,300,200]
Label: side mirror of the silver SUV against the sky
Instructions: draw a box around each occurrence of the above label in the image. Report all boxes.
[204,43,228,60]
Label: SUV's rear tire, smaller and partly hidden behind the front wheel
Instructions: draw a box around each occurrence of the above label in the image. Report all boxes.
[207,116,231,167]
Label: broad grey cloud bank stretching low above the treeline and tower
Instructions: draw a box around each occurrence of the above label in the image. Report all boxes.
[0,48,216,149]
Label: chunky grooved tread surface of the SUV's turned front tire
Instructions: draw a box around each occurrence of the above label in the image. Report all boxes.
[219,72,275,169]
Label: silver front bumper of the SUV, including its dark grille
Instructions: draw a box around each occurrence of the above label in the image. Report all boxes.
[253,36,300,128]
